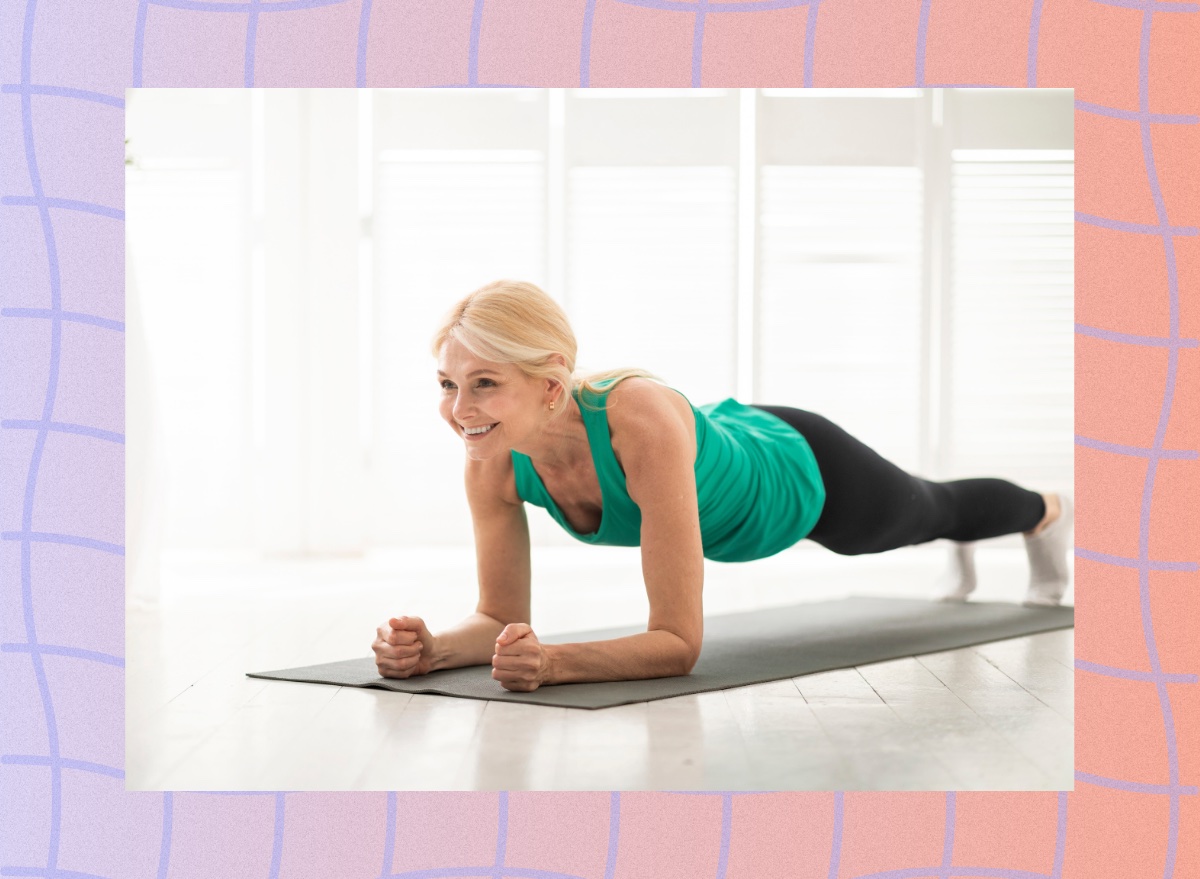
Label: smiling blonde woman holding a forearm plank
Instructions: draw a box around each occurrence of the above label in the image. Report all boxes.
[372,281,1072,692]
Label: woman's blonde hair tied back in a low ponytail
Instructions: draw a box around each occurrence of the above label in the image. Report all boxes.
[431,281,662,417]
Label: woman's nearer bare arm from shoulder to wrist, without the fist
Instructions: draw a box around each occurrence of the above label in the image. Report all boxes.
[544,383,704,683]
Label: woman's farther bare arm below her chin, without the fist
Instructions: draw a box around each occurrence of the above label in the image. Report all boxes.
[432,455,530,669]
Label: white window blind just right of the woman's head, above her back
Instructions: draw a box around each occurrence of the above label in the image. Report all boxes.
[566,166,737,405]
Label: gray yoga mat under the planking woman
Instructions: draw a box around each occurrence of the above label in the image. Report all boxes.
[247,596,1075,708]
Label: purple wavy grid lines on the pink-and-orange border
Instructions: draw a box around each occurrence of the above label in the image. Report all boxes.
[0,0,1200,879]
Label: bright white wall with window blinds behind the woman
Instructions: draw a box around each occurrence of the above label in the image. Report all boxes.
[126,89,1073,555]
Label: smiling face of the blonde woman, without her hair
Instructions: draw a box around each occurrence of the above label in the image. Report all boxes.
[438,339,548,459]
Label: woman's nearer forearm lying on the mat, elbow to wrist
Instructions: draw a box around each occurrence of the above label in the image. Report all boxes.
[542,629,692,683]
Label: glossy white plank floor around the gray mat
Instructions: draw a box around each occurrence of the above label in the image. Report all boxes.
[126,544,1074,790]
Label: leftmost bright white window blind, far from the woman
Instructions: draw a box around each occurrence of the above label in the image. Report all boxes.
[125,166,254,548]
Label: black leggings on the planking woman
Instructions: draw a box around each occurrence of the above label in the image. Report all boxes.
[755,403,1045,556]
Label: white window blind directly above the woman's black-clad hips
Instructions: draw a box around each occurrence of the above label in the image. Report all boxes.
[754,166,922,470]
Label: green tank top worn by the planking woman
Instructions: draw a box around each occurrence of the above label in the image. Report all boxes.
[512,379,824,562]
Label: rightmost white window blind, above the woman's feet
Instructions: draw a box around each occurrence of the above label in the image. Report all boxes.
[944,150,1074,488]
